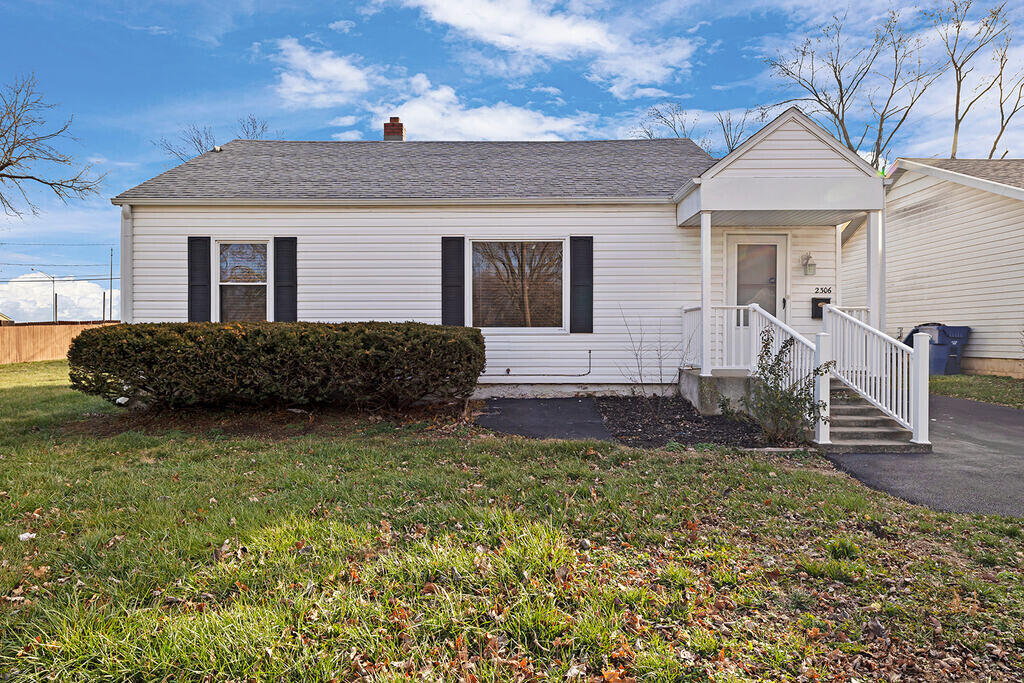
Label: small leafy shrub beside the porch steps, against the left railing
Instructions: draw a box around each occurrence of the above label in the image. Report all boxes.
[743,328,835,445]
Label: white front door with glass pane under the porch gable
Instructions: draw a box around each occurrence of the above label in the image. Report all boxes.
[724,234,788,367]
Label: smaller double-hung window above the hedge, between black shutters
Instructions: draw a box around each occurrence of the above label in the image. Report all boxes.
[219,243,267,323]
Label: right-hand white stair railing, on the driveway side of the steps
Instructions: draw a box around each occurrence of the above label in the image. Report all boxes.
[822,305,929,443]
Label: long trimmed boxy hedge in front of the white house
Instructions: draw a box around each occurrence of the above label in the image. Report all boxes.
[68,323,483,409]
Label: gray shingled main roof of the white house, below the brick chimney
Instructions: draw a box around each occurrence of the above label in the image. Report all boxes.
[114,139,715,202]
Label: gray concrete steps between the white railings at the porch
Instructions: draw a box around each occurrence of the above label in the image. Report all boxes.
[819,379,932,454]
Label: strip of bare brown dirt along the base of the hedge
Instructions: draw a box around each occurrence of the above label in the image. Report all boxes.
[62,403,469,440]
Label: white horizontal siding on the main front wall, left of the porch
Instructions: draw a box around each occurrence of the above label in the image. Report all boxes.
[133,205,699,384]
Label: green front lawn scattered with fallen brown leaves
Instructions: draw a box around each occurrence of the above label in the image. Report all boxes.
[0,362,1024,681]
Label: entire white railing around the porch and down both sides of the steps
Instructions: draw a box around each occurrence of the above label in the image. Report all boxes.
[682,304,929,443]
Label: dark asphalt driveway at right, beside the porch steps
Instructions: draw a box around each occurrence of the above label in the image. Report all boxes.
[828,396,1024,517]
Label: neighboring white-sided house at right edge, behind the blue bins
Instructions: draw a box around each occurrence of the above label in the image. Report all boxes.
[842,159,1024,377]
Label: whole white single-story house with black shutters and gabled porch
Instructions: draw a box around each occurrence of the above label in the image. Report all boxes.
[113,109,927,450]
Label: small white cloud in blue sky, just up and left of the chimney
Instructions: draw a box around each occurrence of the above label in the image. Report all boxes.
[273,38,372,108]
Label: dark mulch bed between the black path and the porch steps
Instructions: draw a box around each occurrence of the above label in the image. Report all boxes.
[597,396,764,447]
